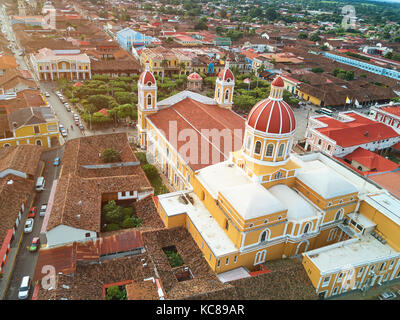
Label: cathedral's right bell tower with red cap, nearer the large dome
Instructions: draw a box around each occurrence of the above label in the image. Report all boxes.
[214,59,235,109]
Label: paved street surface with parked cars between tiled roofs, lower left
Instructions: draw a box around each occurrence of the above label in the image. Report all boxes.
[5,148,63,300]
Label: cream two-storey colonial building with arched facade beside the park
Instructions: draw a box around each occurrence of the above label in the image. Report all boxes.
[30,48,92,80]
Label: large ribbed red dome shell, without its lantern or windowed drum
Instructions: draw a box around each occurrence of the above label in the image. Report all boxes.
[247,98,296,134]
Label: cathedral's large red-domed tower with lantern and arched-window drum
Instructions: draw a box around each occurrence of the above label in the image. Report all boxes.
[233,76,296,182]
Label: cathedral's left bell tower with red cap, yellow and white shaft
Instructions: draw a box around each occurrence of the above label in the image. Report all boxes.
[137,61,157,149]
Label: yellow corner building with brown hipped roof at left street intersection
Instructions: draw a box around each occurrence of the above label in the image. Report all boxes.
[0,107,62,148]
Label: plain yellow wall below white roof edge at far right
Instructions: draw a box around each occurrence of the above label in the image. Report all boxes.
[359,201,400,251]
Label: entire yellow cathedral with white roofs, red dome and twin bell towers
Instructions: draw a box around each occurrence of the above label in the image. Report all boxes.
[138,62,400,297]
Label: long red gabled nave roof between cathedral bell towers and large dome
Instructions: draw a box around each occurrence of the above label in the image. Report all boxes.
[148,98,245,170]
